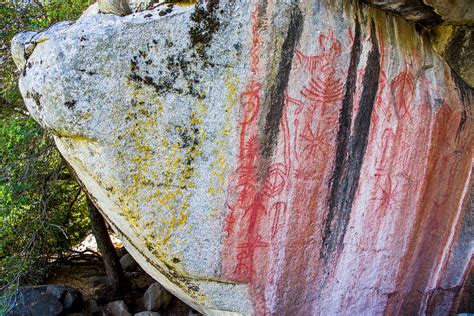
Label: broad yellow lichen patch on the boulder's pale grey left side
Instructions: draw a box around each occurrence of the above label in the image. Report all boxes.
[115,79,207,267]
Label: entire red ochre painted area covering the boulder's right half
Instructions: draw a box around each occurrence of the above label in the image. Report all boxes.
[222,3,472,315]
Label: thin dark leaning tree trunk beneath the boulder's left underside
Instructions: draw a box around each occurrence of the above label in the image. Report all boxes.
[87,198,128,296]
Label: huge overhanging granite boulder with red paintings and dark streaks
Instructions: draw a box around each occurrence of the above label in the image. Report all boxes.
[13,0,474,315]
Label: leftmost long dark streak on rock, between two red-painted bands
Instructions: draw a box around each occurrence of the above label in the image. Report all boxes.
[261,5,303,157]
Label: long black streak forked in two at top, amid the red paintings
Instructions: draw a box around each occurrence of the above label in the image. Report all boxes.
[320,20,380,261]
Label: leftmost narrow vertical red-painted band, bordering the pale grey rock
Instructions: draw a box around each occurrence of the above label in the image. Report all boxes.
[224,5,270,281]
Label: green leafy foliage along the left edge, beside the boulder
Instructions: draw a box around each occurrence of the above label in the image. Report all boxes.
[0,0,90,314]
